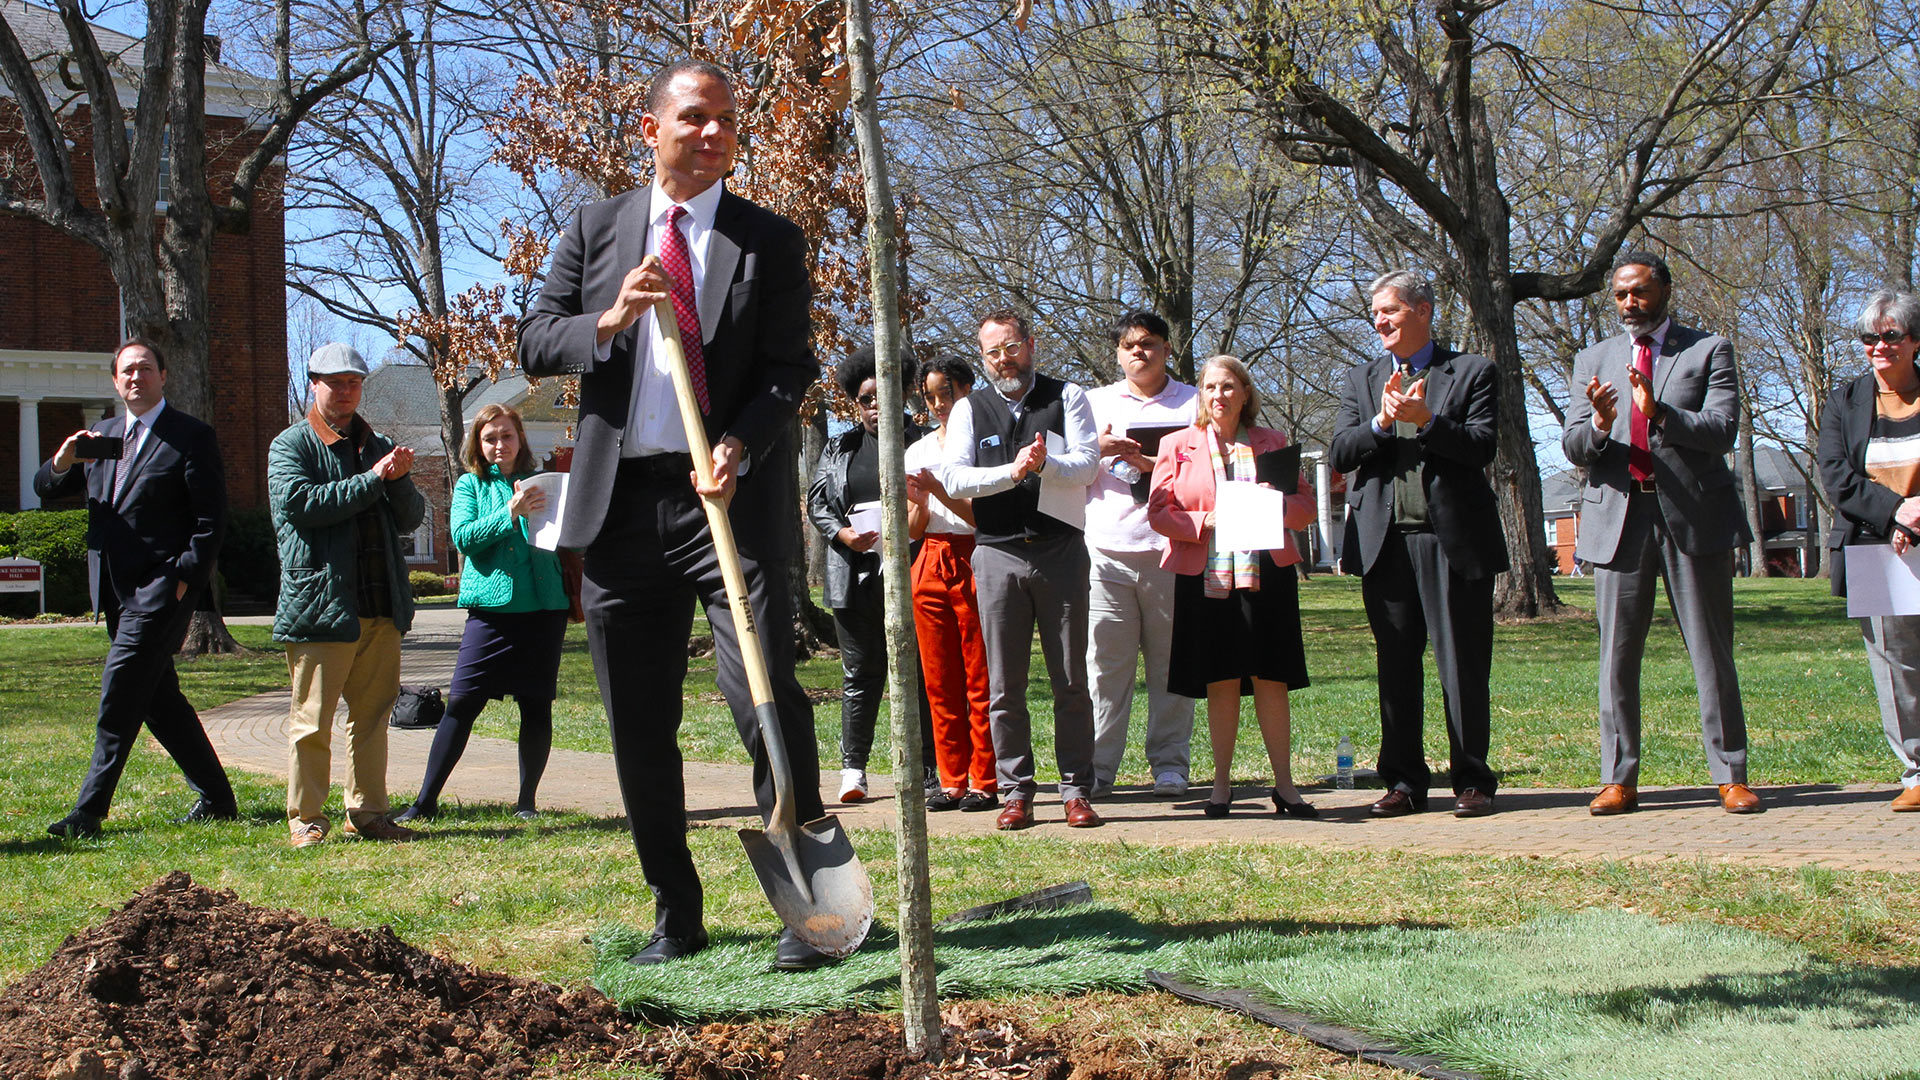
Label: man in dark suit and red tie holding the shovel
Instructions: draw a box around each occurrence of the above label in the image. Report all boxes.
[520,60,828,970]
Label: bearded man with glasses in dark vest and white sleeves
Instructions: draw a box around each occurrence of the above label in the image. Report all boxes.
[941,311,1100,828]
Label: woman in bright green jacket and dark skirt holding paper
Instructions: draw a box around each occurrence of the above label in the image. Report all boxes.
[396,405,568,821]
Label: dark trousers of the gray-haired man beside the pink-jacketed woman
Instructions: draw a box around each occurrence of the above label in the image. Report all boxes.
[1359,527,1498,807]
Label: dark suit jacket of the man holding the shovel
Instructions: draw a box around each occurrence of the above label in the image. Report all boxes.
[520,186,820,559]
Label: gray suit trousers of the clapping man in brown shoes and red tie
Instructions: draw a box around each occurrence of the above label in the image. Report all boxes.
[1594,492,1747,786]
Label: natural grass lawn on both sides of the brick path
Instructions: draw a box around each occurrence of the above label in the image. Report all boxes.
[0,578,1920,1006]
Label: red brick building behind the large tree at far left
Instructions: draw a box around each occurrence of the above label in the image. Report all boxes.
[0,0,286,511]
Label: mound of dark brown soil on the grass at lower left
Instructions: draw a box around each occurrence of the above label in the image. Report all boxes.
[0,872,626,1080]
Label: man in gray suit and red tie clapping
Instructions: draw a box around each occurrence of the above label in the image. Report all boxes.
[1561,254,1761,815]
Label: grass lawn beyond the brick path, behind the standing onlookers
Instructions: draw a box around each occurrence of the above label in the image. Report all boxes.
[476,575,1895,788]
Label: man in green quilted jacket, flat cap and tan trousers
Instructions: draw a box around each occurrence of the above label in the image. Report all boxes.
[267,342,426,847]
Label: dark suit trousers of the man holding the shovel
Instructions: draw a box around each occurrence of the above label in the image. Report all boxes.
[582,459,826,938]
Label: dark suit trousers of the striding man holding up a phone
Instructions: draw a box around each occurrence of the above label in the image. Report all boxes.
[75,582,234,817]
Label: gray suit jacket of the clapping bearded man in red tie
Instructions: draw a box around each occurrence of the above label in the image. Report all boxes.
[1561,323,1753,565]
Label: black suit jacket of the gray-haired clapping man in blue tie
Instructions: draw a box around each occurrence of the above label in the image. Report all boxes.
[1329,346,1507,580]
